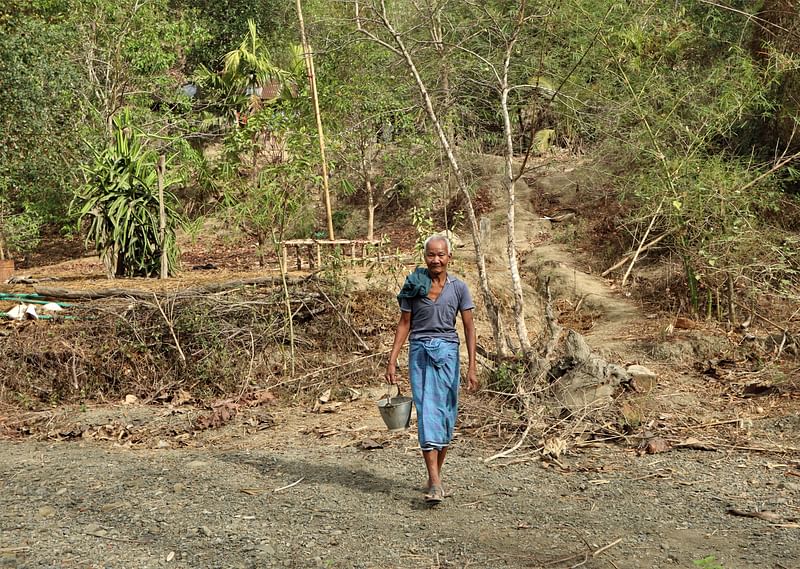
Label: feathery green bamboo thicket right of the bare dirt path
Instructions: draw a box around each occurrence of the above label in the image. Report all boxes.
[588,3,800,311]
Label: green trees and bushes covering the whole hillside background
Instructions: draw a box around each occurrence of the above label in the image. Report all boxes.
[0,0,800,310]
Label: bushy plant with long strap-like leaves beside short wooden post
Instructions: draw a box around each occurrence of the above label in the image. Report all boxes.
[73,114,180,276]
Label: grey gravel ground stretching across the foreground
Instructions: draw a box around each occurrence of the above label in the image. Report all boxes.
[0,408,800,569]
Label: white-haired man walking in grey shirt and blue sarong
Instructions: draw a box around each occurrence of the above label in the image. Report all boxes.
[386,235,478,504]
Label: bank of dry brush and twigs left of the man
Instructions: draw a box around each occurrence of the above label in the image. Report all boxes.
[0,278,391,408]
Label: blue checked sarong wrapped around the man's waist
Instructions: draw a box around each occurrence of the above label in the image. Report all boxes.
[408,338,460,450]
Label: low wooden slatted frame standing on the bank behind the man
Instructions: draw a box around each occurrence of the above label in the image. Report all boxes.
[280,239,384,271]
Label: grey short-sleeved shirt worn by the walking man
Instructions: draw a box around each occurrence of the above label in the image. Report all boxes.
[400,275,475,343]
